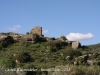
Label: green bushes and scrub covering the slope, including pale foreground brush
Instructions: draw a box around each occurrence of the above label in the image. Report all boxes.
[0,34,100,75]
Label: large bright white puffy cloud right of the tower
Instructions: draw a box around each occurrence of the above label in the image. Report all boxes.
[66,33,94,41]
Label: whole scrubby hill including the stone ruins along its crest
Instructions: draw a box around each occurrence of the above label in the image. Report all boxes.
[0,26,100,75]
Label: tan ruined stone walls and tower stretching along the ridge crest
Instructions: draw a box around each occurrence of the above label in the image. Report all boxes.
[0,26,80,49]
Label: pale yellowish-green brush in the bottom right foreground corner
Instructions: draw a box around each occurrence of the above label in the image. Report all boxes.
[48,65,100,75]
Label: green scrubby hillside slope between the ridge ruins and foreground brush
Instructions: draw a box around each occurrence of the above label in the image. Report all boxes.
[0,38,100,75]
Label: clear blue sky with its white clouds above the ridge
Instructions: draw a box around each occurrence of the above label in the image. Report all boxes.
[0,0,100,45]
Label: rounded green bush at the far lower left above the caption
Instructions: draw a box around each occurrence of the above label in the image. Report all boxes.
[0,58,16,68]
